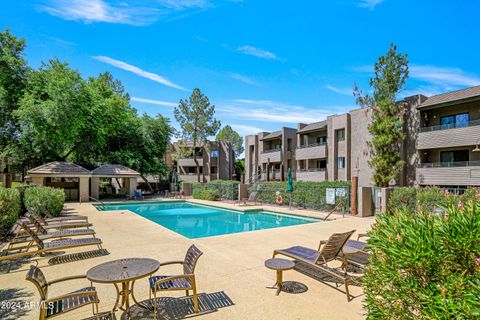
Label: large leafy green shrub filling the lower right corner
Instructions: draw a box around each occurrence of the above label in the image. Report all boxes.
[364,204,480,320]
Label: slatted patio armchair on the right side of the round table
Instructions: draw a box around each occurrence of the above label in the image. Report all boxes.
[148,244,203,319]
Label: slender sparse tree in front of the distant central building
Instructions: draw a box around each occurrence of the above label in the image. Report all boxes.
[174,88,221,182]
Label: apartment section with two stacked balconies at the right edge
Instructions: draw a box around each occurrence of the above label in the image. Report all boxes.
[416,86,480,188]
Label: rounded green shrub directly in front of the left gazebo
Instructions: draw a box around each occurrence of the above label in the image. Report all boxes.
[24,187,65,217]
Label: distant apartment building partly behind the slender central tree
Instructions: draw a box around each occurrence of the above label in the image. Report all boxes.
[170,141,235,182]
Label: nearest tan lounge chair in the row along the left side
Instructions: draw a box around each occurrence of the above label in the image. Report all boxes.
[0,222,102,261]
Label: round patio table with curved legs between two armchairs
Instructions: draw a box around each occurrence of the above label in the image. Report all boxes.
[87,258,160,317]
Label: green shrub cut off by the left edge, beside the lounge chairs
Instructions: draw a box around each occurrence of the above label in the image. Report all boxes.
[0,187,20,237]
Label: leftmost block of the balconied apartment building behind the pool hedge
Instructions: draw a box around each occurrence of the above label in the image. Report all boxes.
[245,127,297,183]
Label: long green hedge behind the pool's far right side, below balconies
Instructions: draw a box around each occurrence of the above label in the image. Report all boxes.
[250,181,350,210]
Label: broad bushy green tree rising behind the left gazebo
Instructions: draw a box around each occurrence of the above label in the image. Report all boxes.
[13,59,94,162]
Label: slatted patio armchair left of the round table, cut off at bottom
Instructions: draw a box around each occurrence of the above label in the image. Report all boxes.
[26,265,100,320]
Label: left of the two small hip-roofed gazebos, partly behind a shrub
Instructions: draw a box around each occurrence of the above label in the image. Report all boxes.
[28,161,91,201]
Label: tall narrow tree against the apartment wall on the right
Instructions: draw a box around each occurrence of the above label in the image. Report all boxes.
[354,44,408,187]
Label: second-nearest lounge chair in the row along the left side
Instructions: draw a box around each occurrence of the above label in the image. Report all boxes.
[7,219,95,251]
